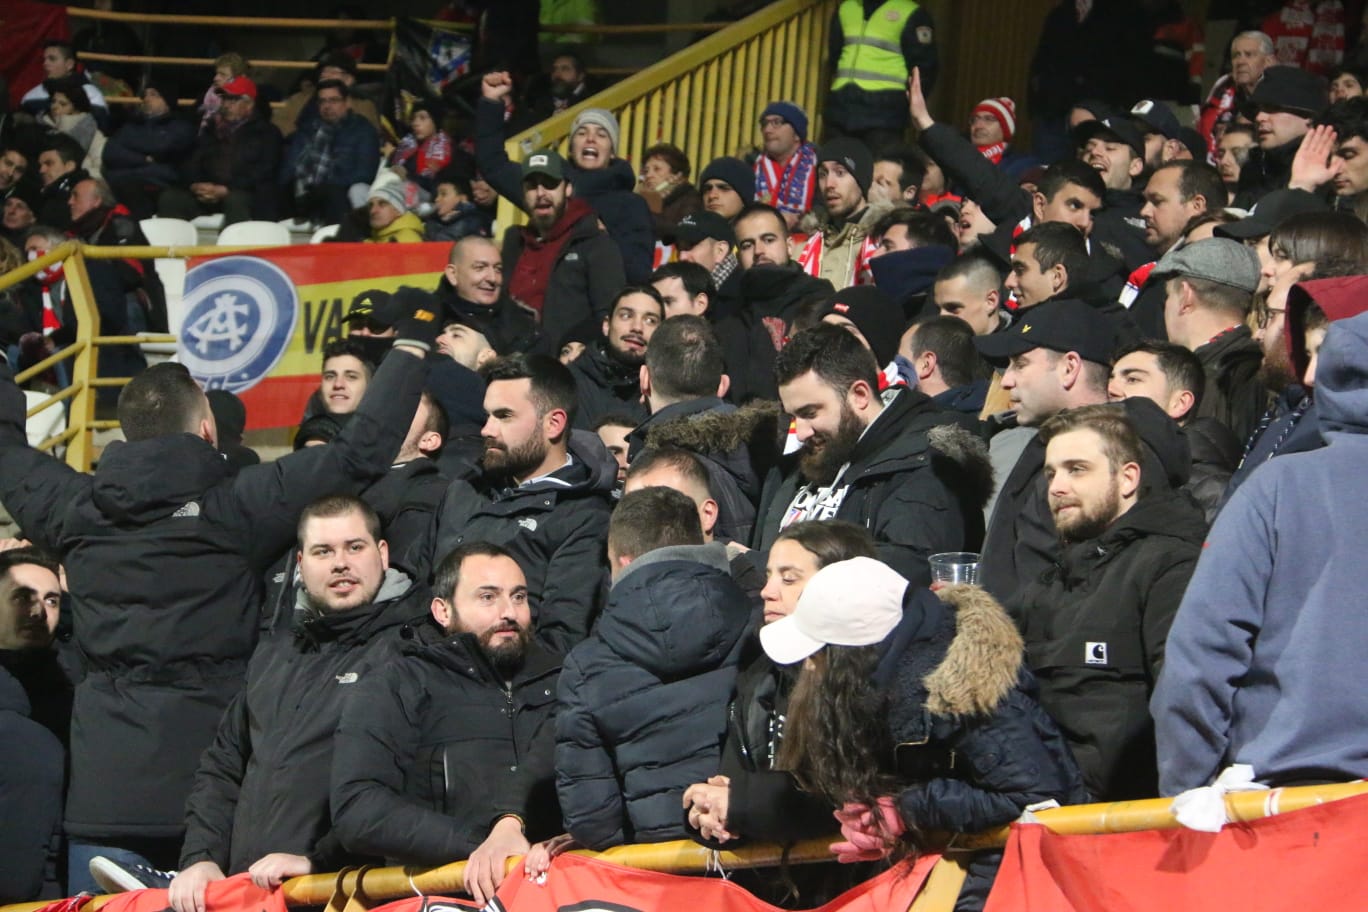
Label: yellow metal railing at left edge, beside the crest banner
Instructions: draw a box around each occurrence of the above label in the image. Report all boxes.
[0,241,279,472]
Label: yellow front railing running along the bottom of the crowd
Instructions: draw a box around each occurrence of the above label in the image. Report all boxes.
[0,781,1368,912]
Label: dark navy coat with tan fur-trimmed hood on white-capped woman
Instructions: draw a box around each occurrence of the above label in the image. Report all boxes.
[874,587,1088,909]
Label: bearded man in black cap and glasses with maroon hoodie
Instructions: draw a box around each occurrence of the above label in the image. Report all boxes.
[503,150,627,345]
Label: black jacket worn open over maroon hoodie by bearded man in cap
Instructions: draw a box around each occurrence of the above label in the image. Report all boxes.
[503,205,627,351]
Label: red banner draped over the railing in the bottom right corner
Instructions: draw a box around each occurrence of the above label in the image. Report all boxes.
[985,792,1368,912]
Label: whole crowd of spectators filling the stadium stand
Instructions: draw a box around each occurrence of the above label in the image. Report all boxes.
[0,0,1368,912]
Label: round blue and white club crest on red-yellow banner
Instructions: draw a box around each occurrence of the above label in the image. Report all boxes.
[176,257,300,392]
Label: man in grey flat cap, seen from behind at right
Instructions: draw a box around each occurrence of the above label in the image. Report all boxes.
[1155,238,1268,440]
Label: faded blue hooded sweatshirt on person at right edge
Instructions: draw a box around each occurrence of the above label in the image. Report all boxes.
[1150,316,1368,794]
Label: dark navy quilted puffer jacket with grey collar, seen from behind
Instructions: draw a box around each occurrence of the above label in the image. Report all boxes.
[555,543,751,849]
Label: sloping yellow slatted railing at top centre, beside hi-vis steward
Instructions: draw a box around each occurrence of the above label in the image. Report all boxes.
[498,0,836,226]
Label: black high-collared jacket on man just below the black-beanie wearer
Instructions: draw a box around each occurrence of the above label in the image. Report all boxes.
[717,263,836,402]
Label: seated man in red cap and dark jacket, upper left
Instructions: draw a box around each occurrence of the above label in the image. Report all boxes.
[157,77,280,226]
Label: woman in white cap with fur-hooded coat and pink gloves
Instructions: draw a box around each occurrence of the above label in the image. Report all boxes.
[761,556,1088,911]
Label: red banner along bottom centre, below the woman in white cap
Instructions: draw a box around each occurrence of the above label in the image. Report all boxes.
[491,855,940,912]
